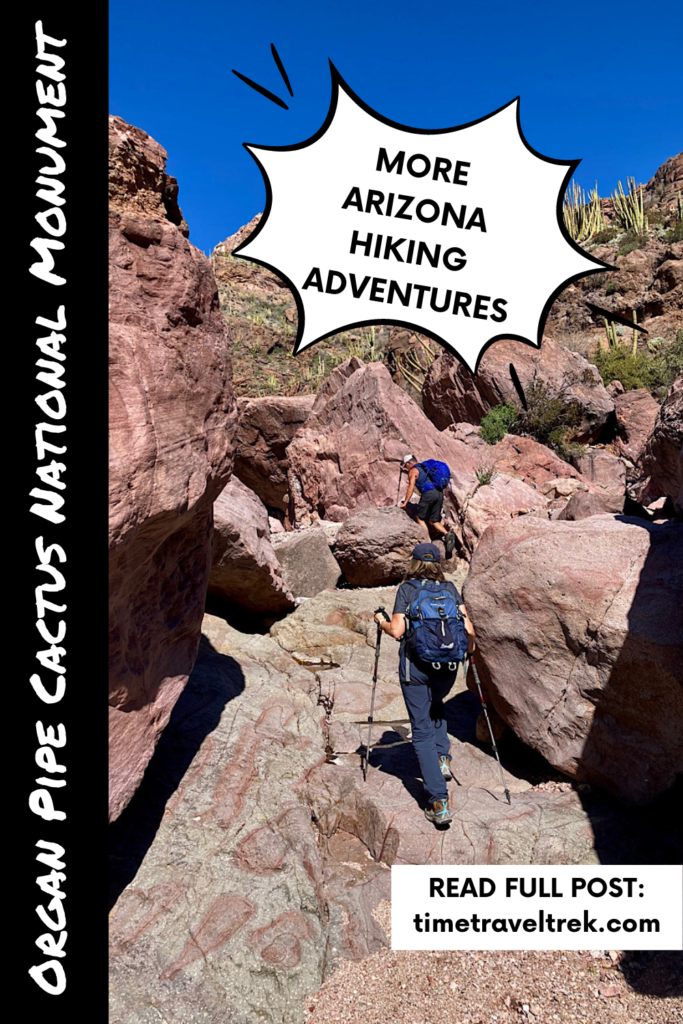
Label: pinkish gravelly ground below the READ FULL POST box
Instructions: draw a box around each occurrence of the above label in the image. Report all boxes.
[304,904,683,1024]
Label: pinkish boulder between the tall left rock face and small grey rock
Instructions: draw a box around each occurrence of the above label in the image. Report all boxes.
[209,476,295,615]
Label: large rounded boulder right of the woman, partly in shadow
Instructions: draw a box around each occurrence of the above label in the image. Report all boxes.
[464,515,683,803]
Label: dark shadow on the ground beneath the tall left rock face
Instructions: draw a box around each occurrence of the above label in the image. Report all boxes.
[109,636,245,910]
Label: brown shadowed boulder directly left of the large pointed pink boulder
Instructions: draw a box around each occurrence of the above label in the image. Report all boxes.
[234,394,315,512]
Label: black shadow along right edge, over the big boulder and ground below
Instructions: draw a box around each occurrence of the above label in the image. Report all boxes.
[580,517,683,863]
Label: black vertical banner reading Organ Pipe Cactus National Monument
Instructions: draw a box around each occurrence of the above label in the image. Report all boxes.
[17,9,108,1024]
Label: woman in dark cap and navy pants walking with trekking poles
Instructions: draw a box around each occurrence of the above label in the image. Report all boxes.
[375,544,474,825]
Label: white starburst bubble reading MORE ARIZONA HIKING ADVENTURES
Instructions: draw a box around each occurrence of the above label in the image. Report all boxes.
[233,63,610,372]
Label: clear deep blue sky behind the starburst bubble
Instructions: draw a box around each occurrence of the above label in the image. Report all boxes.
[110,0,683,251]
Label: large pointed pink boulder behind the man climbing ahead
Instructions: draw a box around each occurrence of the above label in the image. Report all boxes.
[288,359,477,523]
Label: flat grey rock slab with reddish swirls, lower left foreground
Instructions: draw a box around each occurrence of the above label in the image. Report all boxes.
[110,615,331,1024]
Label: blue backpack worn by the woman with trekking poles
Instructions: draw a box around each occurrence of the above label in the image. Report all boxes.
[405,580,468,678]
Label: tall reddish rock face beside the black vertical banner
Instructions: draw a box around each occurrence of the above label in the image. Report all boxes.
[110,118,236,818]
